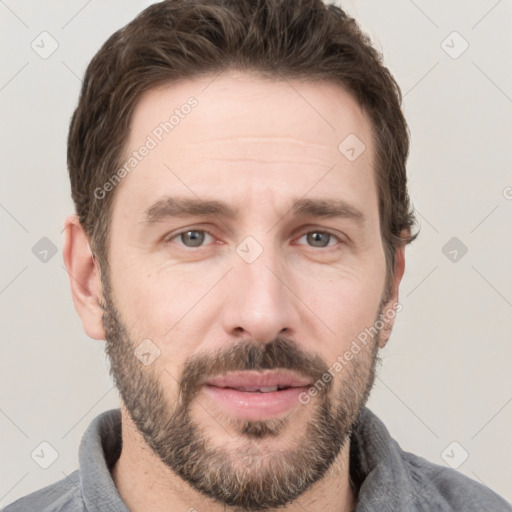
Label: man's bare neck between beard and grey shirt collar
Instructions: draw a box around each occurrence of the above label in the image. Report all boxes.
[112,407,357,512]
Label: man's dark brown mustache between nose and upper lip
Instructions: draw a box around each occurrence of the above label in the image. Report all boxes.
[179,337,333,403]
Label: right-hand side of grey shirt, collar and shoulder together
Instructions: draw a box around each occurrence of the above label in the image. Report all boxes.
[350,407,512,512]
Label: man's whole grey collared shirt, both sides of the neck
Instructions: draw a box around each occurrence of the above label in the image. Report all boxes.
[3,407,512,512]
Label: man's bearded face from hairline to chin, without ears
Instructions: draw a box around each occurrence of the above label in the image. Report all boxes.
[104,73,394,509]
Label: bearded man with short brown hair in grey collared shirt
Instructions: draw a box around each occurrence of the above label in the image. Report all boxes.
[5,0,509,512]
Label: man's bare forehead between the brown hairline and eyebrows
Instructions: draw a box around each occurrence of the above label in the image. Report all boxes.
[116,71,374,218]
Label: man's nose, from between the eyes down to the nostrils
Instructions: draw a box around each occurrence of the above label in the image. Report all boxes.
[222,241,300,343]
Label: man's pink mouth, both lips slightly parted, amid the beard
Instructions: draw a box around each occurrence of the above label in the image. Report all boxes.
[203,370,311,421]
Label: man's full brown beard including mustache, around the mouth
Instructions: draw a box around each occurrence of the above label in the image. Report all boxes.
[103,286,382,510]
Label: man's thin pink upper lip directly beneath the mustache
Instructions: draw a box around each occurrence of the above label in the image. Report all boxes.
[205,370,310,388]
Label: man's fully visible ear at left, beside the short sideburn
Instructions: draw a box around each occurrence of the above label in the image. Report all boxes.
[64,215,105,340]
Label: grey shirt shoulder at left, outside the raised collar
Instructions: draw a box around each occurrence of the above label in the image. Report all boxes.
[2,470,85,512]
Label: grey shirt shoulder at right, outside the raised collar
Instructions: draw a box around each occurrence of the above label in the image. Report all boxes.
[401,450,512,512]
